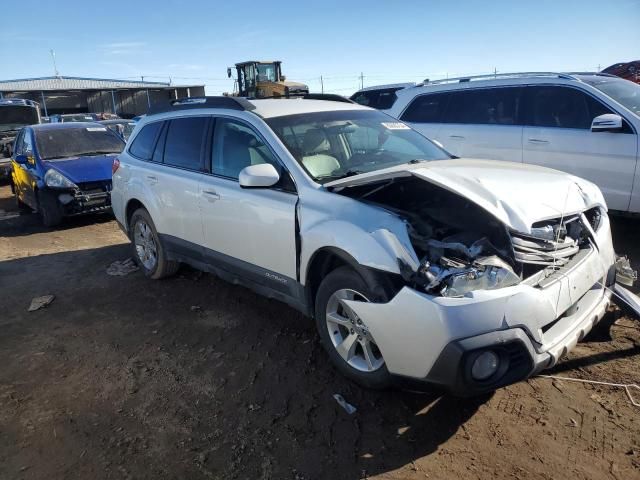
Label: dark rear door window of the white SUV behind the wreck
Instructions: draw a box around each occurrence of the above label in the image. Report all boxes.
[445,88,520,125]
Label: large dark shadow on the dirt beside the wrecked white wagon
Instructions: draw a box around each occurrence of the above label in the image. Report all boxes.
[0,244,490,479]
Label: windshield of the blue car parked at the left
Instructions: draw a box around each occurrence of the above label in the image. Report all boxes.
[36,126,124,160]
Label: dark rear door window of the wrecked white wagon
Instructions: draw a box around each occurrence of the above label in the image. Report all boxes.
[164,117,209,170]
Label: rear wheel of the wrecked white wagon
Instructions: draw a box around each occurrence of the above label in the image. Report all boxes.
[129,208,180,280]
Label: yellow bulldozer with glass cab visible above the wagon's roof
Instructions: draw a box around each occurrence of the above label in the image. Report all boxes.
[227,60,309,98]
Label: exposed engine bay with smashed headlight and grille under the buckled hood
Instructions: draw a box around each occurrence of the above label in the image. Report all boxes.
[339,177,600,297]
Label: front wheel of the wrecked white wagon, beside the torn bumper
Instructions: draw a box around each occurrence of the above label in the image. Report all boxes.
[315,267,392,389]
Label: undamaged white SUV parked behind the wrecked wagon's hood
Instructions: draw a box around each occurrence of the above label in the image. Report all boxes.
[351,73,640,213]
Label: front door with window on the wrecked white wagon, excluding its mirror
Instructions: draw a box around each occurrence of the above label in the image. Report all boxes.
[200,118,298,295]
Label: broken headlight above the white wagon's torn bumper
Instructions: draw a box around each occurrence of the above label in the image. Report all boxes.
[422,255,520,297]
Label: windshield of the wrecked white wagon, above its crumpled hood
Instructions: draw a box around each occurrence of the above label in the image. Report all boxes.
[267,110,451,183]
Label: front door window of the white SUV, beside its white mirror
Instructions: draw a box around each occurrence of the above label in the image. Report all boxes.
[527,86,592,129]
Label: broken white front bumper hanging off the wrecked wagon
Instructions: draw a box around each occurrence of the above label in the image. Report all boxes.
[348,219,615,396]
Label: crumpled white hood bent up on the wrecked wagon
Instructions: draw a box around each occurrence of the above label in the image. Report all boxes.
[325,159,606,233]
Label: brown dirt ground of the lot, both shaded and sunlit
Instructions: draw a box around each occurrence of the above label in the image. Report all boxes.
[0,186,640,480]
